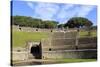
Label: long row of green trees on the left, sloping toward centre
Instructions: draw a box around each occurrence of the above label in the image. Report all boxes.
[11,16,58,28]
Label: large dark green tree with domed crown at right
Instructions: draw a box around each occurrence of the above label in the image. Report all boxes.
[65,17,92,28]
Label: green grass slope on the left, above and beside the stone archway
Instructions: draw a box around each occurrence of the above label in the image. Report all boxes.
[12,31,49,47]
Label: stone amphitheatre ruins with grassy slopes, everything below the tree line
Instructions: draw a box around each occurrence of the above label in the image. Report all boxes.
[11,26,97,66]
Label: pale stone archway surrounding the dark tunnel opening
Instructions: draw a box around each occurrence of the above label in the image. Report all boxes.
[26,42,42,59]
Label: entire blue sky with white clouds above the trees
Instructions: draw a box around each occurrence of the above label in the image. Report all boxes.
[12,0,97,25]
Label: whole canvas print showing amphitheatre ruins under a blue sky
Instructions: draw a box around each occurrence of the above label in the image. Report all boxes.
[10,1,98,66]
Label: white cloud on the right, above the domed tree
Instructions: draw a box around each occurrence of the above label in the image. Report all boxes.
[57,5,94,22]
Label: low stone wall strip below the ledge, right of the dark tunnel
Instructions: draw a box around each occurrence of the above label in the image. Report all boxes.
[43,50,97,59]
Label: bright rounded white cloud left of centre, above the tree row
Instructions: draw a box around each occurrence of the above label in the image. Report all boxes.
[35,3,59,20]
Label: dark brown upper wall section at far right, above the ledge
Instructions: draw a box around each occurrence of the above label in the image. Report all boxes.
[78,37,97,49]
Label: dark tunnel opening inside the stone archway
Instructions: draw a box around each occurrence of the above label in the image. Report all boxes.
[30,45,42,59]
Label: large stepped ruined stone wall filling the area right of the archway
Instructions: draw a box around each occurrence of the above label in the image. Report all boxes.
[41,32,97,59]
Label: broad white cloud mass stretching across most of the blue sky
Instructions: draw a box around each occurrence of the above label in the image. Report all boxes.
[27,2,94,22]
